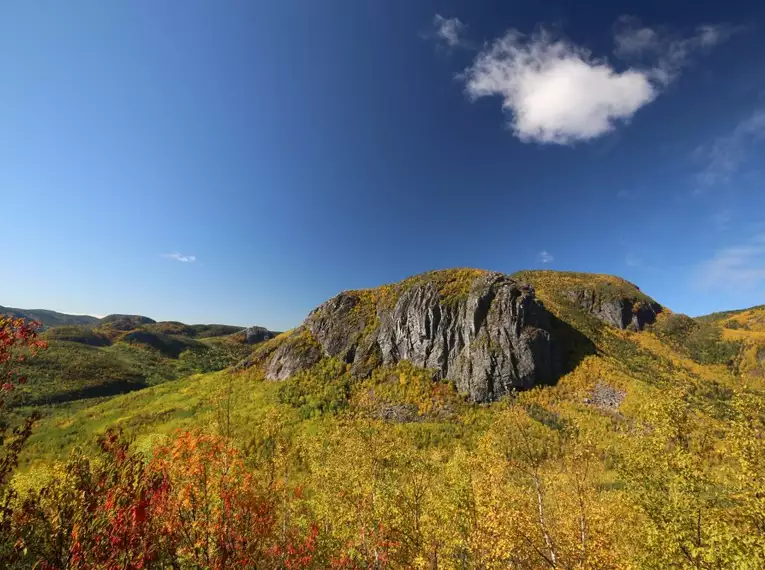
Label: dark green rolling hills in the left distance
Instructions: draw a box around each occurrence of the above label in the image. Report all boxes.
[3,311,276,407]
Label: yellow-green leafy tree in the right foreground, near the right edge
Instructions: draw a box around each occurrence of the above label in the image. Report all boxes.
[618,390,736,569]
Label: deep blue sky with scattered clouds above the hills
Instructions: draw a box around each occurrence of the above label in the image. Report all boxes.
[0,0,765,329]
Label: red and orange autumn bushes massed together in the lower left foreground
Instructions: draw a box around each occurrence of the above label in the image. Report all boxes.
[16,431,319,570]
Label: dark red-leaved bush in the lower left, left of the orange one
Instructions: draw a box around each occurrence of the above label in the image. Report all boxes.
[14,430,172,570]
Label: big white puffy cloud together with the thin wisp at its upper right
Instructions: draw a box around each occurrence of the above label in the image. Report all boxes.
[459,20,725,144]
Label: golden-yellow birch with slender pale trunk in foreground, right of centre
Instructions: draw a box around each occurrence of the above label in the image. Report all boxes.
[468,404,623,569]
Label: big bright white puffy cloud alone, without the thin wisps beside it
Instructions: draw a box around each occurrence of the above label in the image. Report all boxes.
[464,30,657,144]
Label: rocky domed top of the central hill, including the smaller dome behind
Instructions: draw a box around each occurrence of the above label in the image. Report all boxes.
[245,269,662,402]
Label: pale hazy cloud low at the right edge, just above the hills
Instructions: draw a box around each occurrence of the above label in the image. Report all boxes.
[698,234,765,290]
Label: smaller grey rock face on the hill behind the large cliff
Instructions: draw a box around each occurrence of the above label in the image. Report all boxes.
[568,289,661,330]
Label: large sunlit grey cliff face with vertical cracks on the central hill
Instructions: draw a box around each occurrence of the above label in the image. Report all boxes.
[266,272,561,402]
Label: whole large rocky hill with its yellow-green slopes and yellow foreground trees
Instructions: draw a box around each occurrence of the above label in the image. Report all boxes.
[7,269,765,570]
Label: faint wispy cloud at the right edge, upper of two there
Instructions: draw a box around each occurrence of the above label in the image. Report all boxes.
[694,109,765,187]
